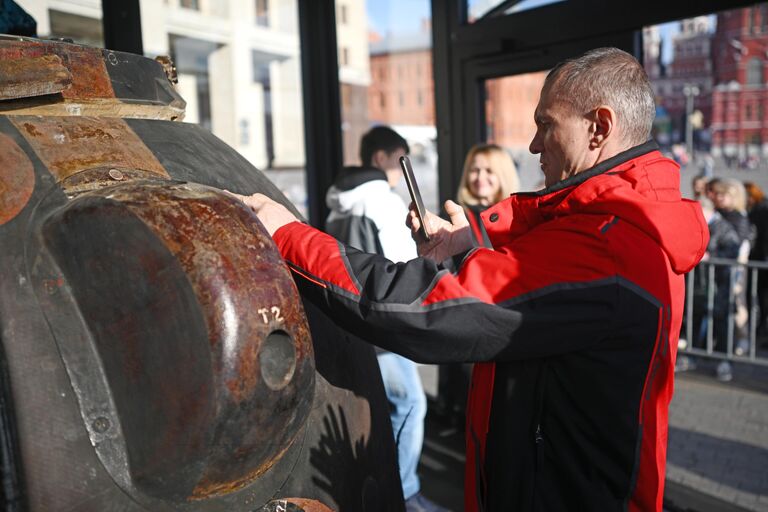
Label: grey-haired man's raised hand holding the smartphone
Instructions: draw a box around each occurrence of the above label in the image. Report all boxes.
[405,200,474,262]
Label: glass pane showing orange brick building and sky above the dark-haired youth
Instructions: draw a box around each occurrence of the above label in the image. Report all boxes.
[336,0,438,211]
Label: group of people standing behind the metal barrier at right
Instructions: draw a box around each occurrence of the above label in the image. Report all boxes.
[677,174,768,381]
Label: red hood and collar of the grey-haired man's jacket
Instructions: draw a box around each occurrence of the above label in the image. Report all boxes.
[483,142,709,274]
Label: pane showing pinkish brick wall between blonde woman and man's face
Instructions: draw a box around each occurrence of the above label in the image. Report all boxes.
[485,71,547,191]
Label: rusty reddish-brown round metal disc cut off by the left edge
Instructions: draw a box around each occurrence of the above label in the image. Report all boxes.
[0,133,35,226]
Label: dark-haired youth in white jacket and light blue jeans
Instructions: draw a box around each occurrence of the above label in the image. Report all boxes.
[325,126,444,512]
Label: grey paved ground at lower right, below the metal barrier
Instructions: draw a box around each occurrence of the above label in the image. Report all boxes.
[667,373,768,512]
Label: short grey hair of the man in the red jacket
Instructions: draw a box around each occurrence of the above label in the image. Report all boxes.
[544,48,656,146]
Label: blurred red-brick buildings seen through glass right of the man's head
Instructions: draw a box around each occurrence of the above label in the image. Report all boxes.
[643,3,768,183]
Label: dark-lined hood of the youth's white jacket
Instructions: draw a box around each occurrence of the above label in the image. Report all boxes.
[325,167,390,213]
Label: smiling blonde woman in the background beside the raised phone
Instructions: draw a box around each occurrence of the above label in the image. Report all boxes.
[457,144,520,246]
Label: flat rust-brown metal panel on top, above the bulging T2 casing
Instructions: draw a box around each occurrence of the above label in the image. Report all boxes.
[10,116,168,180]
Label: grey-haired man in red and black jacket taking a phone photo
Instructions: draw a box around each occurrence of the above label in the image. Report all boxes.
[232,48,708,511]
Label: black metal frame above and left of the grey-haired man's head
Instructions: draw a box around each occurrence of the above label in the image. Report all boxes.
[432,0,756,202]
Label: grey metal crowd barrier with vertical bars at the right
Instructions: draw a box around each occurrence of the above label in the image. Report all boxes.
[678,258,768,366]
